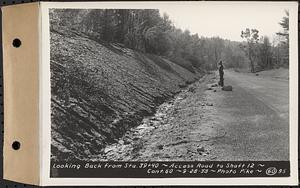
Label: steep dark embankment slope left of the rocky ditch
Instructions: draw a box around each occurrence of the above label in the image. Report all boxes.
[50,30,197,161]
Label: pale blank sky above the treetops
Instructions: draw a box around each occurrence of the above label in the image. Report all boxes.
[160,2,287,41]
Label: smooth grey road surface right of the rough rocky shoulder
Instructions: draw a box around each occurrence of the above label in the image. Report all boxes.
[208,72,289,160]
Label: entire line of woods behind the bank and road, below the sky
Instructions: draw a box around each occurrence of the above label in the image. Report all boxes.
[50,9,288,72]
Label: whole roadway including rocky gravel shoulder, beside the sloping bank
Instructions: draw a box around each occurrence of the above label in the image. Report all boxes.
[99,71,289,161]
